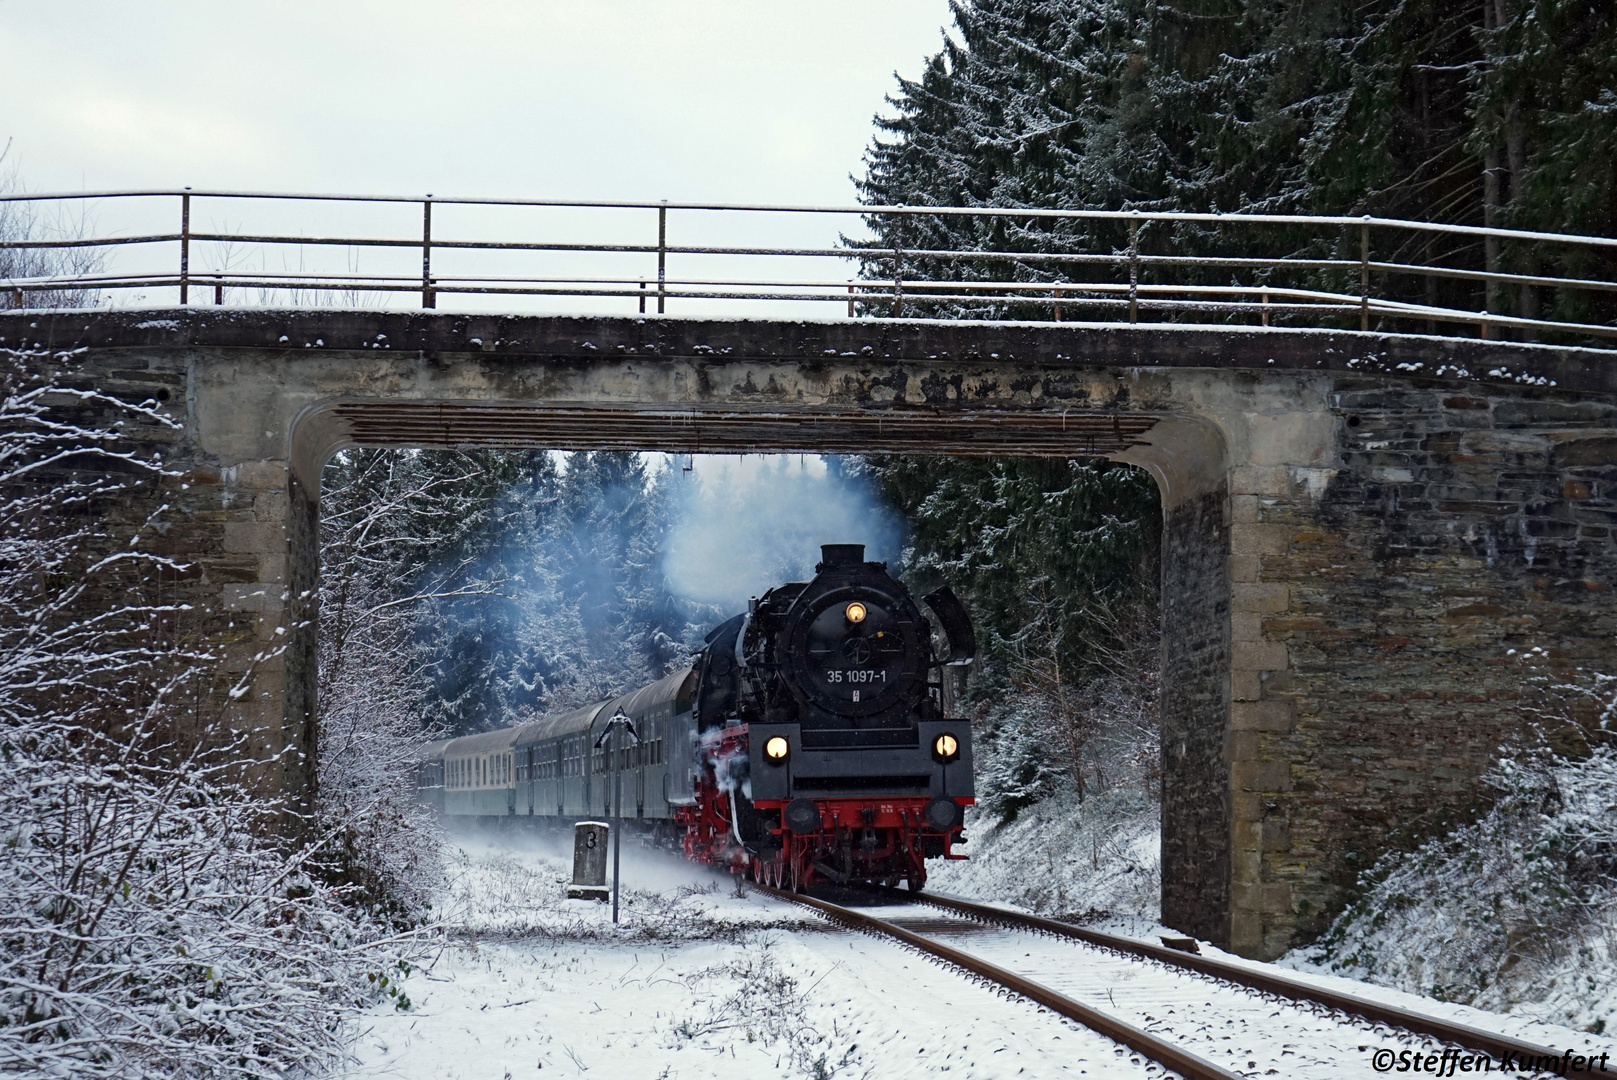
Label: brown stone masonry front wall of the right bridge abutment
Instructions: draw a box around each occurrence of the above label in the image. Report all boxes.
[1228,378,1617,956]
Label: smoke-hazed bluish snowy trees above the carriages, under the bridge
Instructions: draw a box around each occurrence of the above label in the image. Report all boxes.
[322,451,695,734]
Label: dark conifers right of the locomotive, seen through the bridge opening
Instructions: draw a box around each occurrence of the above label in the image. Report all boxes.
[863,456,1159,821]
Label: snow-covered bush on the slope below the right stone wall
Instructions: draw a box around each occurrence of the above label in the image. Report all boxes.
[1297,681,1617,1031]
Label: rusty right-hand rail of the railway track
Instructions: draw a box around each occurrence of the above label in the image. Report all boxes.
[905,891,1597,1059]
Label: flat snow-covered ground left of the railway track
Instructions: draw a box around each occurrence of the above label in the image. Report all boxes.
[349,839,1177,1080]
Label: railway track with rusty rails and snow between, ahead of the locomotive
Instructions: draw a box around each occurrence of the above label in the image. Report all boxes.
[755,886,1604,1080]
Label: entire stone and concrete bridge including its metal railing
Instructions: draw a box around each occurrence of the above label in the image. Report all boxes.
[9,189,1617,957]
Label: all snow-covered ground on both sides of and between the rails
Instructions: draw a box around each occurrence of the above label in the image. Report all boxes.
[349,814,1617,1080]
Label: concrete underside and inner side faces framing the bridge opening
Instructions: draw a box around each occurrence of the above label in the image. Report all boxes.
[288,401,1232,941]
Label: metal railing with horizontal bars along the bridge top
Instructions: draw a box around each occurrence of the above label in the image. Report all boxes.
[0,189,1617,348]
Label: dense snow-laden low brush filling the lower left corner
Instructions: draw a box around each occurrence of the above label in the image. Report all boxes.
[0,721,407,1077]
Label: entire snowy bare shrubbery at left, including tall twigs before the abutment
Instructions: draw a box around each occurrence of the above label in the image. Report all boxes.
[0,352,420,1078]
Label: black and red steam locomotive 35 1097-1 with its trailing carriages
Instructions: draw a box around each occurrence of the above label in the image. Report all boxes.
[422,543,977,889]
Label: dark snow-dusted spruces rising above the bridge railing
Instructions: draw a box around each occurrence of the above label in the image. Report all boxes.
[854,0,1617,333]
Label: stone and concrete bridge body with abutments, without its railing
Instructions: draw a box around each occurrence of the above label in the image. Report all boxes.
[12,310,1617,957]
